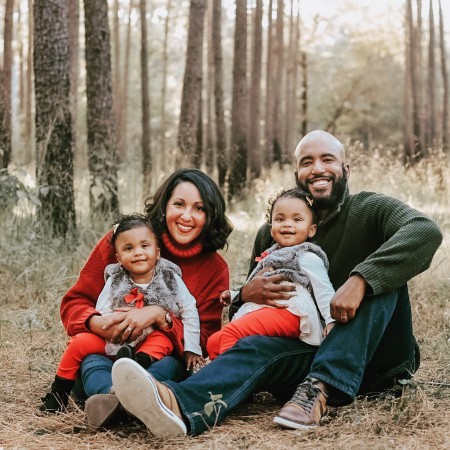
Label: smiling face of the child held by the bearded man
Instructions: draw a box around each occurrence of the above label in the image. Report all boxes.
[271,197,317,247]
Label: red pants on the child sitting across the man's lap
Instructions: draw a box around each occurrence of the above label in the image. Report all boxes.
[206,308,300,359]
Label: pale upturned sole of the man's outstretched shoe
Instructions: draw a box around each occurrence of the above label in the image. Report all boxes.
[112,359,187,437]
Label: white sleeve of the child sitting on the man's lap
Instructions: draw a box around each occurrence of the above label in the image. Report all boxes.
[299,252,335,325]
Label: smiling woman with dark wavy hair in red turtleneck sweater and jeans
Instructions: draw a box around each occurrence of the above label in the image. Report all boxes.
[57,169,233,426]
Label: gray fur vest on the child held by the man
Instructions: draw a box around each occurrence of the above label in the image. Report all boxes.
[247,242,328,298]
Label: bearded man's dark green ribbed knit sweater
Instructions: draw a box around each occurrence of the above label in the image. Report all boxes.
[250,186,442,295]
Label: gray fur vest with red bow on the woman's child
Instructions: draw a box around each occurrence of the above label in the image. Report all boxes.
[105,258,181,317]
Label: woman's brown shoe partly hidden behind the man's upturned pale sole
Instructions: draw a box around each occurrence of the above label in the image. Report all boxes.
[84,394,122,428]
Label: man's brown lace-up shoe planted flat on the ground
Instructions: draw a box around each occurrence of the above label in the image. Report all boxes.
[273,378,328,430]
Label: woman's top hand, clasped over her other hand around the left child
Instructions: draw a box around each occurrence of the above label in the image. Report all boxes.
[111,305,166,344]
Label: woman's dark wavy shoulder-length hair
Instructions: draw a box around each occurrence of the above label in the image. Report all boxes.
[145,169,233,251]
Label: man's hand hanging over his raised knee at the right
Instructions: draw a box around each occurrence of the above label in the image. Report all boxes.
[330,275,367,323]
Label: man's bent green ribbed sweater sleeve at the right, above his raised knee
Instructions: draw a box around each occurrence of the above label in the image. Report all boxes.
[350,194,442,295]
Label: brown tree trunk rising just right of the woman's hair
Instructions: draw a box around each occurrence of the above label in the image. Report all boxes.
[228,0,247,200]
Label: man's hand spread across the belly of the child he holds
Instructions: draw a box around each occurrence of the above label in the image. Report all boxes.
[241,267,295,308]
